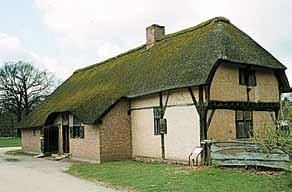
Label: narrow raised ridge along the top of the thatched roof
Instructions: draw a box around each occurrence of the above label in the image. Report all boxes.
[73,16,230,74]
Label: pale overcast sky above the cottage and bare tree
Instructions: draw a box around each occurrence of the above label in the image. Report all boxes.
[0,0,292,82]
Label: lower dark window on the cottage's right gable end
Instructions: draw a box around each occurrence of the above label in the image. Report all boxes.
[235,111,253,139]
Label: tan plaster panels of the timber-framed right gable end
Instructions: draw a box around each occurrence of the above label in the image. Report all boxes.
[207,63,279,140]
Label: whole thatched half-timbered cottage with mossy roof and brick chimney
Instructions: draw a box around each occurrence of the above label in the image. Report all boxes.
[21,17,290,162]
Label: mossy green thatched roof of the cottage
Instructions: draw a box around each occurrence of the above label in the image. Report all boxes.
[20,17,286,128]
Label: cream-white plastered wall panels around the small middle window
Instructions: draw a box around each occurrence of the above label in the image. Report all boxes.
[131,89,200,160]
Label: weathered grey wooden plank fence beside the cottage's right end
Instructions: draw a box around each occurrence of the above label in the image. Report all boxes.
[204,140,292,171]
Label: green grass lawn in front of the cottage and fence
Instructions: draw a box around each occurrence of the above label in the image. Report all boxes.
[67,161,292,192]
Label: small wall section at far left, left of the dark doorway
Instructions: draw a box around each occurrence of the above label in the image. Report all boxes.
[21,129,41,153]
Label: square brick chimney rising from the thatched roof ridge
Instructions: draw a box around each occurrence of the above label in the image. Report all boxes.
[146,24,165,49]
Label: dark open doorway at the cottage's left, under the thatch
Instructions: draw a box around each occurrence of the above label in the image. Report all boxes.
[43,126,59,154]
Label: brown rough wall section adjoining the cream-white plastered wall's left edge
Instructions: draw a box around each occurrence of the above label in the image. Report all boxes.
[98,100,132,162]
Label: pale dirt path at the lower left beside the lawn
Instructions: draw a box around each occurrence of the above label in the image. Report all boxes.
[0,148,120,192]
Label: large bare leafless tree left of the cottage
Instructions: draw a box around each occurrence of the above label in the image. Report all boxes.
[0,61,55,122]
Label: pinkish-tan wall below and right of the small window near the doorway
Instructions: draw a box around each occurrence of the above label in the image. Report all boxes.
[70,125,100,162]
